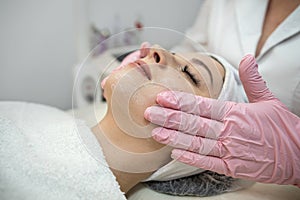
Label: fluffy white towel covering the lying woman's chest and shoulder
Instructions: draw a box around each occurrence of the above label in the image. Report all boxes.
[0,102,126,200]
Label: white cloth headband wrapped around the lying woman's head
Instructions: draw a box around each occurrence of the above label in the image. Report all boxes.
[145,53,247,181]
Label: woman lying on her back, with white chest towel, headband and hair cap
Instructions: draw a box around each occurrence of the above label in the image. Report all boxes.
[0,45,252,199]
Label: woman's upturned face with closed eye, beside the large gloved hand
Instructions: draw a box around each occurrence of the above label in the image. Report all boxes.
[104,45,224,126]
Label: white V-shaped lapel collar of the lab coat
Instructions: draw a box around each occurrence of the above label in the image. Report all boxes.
[235,0,300,59]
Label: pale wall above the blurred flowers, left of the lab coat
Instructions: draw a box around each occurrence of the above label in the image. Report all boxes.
[89,0,203,32]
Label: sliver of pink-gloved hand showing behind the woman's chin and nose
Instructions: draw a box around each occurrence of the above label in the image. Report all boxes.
[101,42,150,89]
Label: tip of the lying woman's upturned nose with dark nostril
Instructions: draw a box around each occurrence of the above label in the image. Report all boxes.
[141,45,165,64]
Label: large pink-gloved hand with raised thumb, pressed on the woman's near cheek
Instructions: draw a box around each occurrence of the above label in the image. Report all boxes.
[145,55,300,187]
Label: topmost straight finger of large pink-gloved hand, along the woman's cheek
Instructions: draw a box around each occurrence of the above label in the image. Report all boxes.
[156,91,234,121]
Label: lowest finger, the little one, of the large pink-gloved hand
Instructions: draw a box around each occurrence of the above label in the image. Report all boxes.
[171,149,229,176]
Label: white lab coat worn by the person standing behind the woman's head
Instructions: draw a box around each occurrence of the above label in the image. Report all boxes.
[176,0,300,116]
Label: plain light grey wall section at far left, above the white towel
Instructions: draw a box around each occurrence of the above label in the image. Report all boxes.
[0,0,76,109]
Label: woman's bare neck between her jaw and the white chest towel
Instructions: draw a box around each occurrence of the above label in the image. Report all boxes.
[92,114,171,193]
